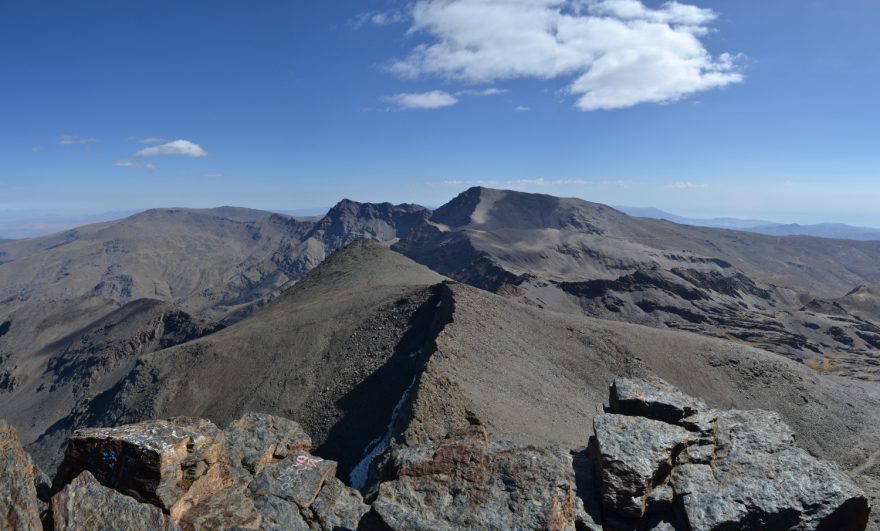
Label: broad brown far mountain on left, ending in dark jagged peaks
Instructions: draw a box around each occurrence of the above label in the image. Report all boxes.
[0,201,428,319]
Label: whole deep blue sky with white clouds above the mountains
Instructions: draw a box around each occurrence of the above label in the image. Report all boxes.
[0,0,880,226]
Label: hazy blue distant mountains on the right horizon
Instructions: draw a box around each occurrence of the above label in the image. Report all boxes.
[615,206,880,241]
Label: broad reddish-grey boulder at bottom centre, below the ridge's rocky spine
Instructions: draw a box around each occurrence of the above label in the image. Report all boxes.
[367,440,576,531]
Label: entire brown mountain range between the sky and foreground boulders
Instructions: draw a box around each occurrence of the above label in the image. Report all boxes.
[0,188,880,523]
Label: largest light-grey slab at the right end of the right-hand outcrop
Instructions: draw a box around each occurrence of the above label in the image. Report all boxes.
[671,411,869,531]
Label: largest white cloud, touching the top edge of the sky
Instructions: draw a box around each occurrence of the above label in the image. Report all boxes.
[390,0,743,111]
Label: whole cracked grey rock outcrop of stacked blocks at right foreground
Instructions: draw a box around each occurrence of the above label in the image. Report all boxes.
[595,379,870,531]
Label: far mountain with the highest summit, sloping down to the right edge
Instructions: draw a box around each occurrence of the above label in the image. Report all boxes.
[394,188,880,380]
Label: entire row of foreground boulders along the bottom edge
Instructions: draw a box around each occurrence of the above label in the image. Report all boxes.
[0,379,870,531]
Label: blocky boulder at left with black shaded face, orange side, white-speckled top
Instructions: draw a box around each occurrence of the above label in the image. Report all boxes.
[55,417,227,512]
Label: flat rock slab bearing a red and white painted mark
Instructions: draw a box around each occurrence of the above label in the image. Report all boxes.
[250,451,337,509]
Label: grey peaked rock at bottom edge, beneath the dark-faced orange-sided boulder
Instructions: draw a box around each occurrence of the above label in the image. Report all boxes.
[51,471,179,531]
